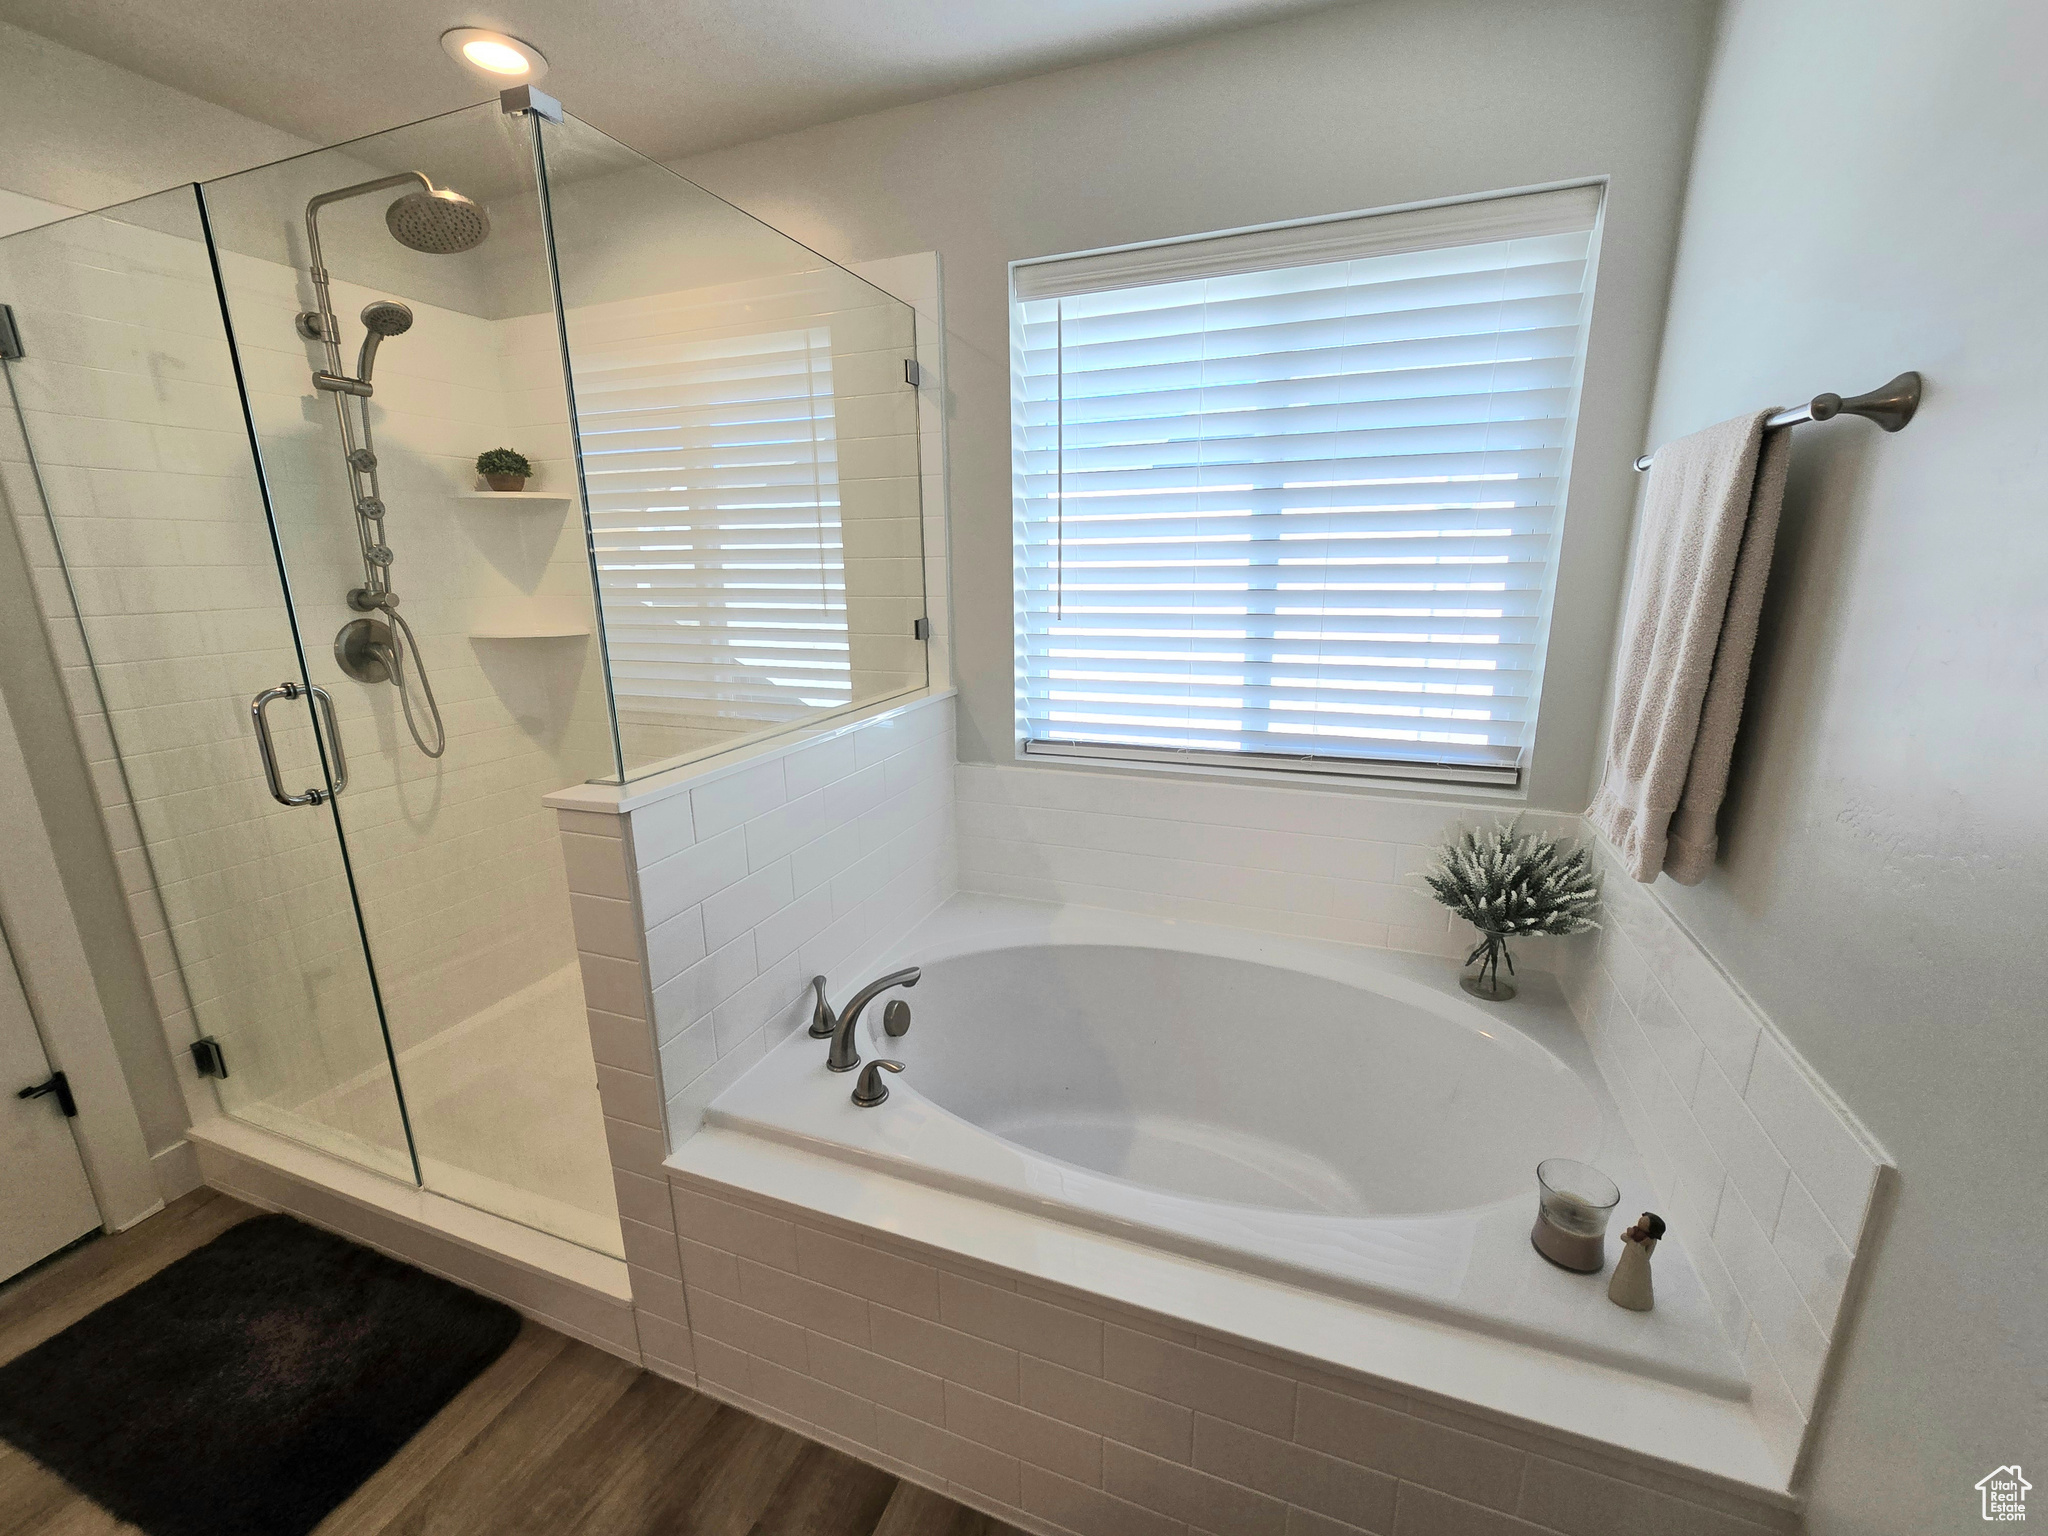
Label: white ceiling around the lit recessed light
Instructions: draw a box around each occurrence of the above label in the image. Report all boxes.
[0,0,1331,160]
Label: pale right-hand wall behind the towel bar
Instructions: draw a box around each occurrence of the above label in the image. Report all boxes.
[1622,0,2048,1536]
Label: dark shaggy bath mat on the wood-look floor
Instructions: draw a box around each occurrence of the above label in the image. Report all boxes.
[0,1217,520,1536]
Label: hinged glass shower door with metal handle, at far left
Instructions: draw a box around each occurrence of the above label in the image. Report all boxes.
[0,186,414,1180]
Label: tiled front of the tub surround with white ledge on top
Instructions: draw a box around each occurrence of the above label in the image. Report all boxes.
[672,1146,1796,1536]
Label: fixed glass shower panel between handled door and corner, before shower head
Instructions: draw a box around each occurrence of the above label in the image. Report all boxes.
[205,102,621,1255]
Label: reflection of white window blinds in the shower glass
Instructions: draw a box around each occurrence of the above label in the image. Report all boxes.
[575,309,852,727]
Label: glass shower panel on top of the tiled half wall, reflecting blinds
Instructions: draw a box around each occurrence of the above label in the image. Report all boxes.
[541,119,926,778]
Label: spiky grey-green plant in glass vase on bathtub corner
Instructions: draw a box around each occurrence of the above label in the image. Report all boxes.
[1421,819,1599,1004]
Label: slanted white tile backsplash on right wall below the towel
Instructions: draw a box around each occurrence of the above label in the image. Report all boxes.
[1563,834,1890,1466]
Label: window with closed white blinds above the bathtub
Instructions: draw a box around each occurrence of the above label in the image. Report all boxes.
[1012,186,1599,784]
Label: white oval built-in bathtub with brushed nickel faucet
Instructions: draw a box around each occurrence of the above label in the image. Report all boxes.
[705,897,1747,1397]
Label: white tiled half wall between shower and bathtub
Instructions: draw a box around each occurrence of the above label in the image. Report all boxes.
[549,694,954,1380]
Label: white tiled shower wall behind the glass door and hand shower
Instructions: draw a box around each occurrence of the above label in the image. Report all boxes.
[0,207,606,1143]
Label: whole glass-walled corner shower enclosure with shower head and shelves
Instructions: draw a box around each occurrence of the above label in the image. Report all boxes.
[0,102,926,1255]
